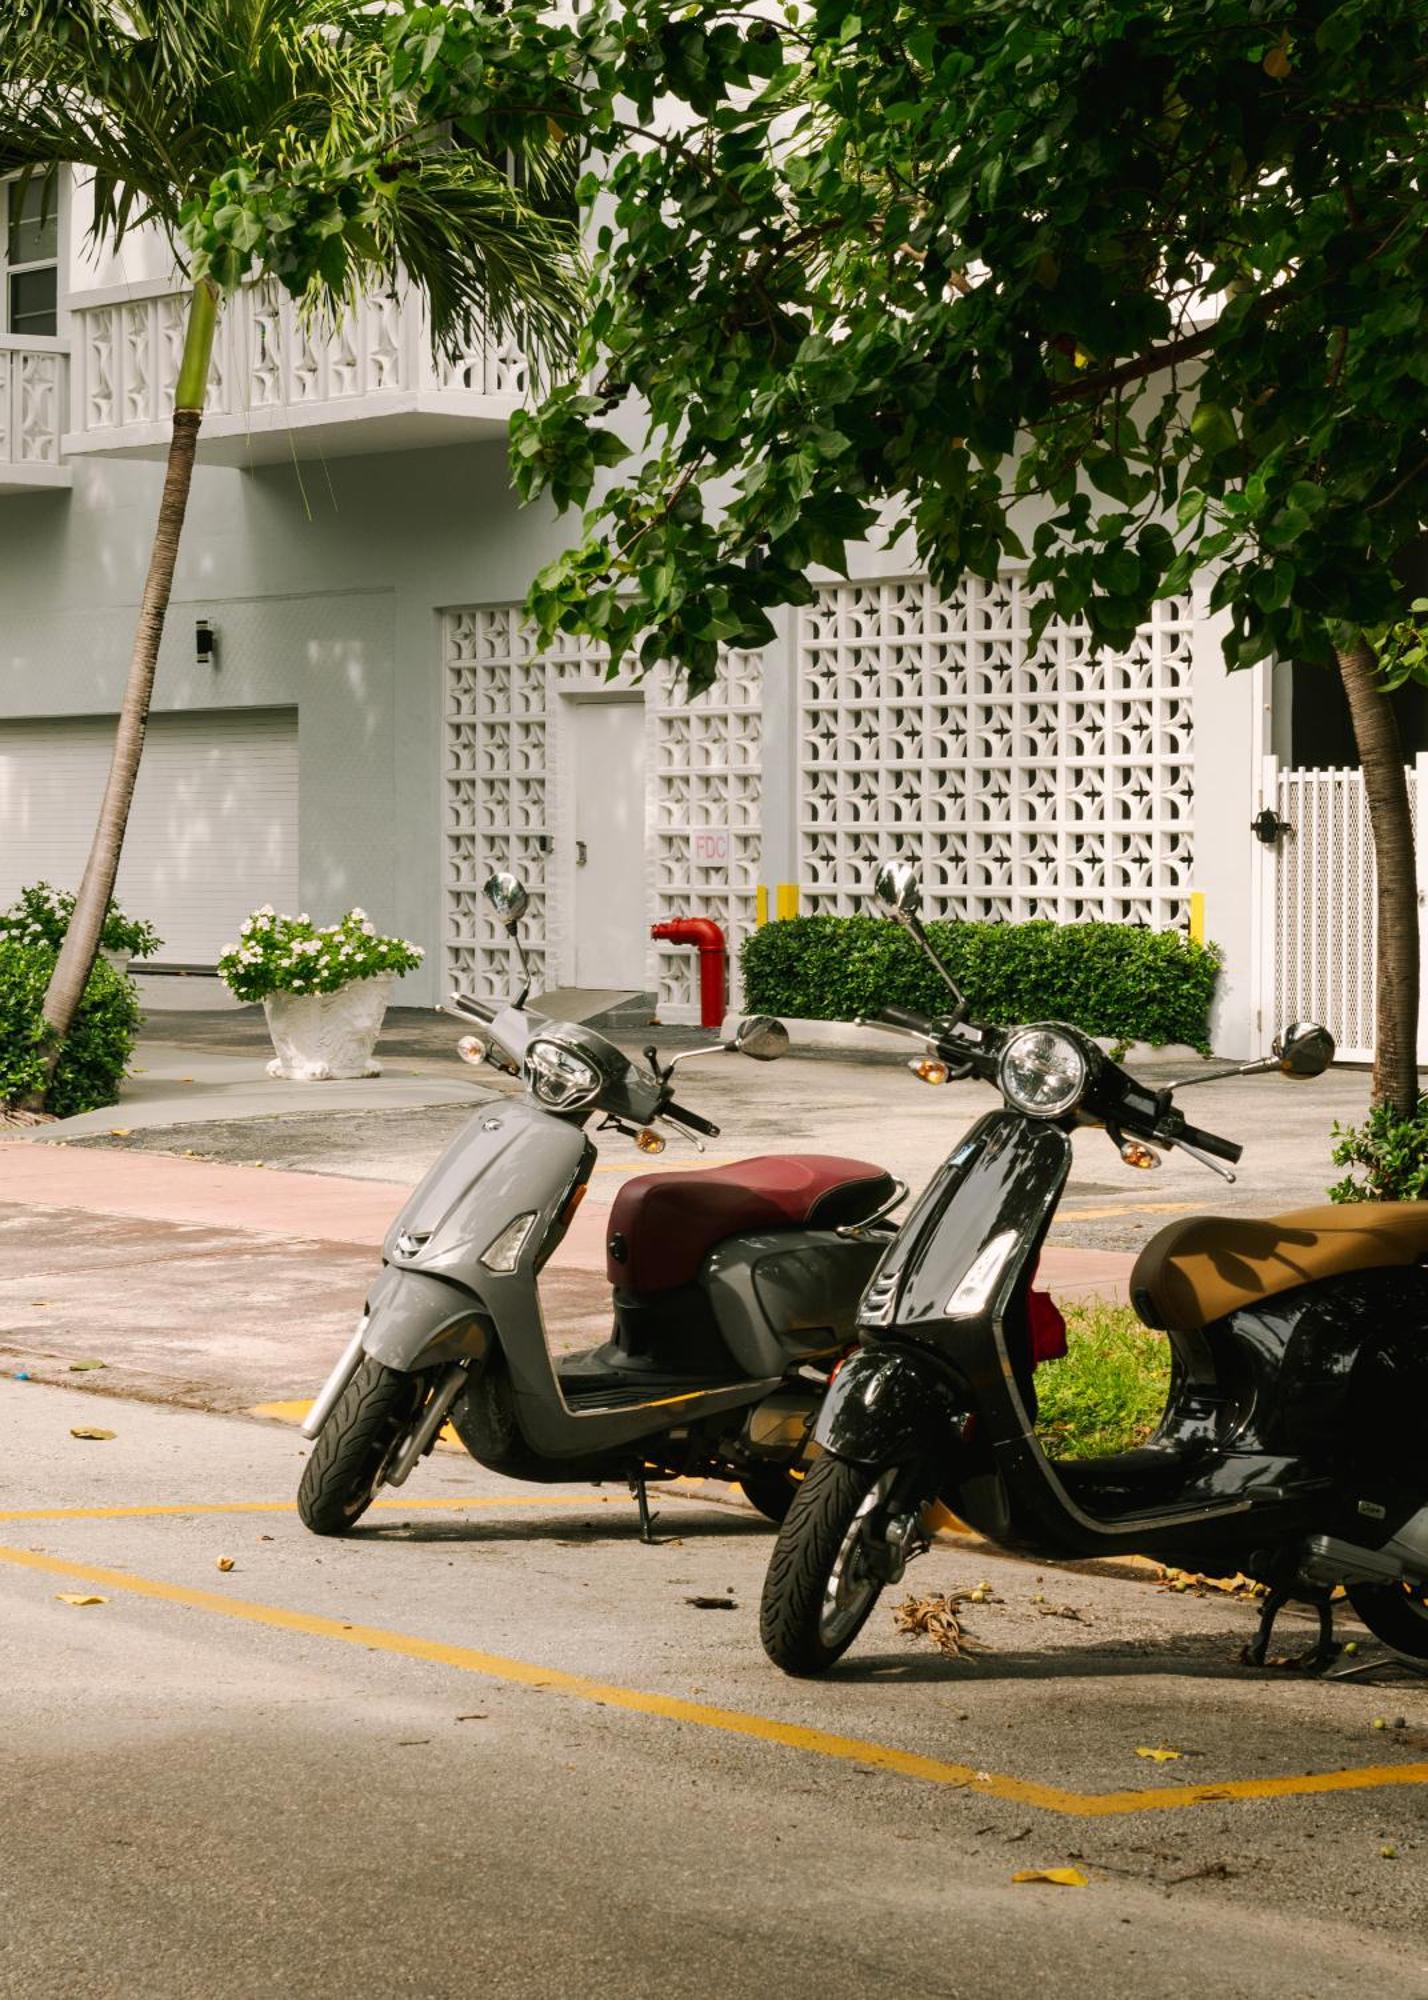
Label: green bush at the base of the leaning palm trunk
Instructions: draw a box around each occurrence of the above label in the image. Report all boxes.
[0,938,140,1118]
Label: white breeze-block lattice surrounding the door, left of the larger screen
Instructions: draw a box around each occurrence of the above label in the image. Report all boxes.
[442,606,762,1020]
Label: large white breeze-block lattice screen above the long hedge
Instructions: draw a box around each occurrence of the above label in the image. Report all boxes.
[798,576,1192,928]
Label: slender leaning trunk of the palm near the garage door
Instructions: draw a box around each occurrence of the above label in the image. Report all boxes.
[30,280,218,1110]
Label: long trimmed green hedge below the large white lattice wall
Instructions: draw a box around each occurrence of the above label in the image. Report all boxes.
[742,916,1220,1052]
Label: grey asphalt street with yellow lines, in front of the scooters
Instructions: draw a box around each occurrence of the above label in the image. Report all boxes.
[0,1380,1428,2000]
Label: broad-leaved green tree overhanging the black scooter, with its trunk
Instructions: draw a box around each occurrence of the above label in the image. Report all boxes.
[408,0,1428,1110]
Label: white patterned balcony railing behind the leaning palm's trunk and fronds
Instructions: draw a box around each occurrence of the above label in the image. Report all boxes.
[64,284,526,466]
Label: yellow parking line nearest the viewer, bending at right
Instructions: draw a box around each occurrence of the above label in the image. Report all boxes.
[0,1548,1428,1818]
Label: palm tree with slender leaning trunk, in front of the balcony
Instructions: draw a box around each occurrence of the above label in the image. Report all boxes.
[0,0,578,1076]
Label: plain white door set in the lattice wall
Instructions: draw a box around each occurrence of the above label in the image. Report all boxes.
[570,694,650,992]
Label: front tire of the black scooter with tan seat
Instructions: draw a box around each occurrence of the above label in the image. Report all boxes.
[758,1452,896,1676]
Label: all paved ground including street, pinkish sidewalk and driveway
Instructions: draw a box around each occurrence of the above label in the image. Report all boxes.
[0,1016,1428,2000]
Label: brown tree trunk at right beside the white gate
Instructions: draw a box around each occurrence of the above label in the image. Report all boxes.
[1330,638,1428,1118]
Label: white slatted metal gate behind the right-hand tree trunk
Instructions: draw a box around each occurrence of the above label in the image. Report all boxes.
[1258,756,1428,1062]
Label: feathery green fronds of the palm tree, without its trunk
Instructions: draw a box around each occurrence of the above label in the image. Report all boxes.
[0,0,578,364]
